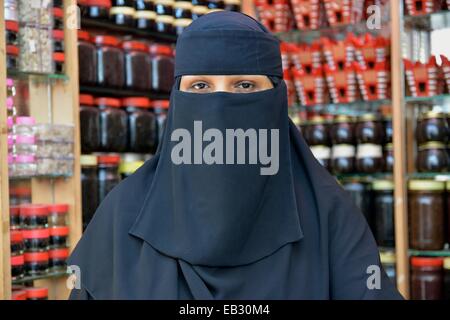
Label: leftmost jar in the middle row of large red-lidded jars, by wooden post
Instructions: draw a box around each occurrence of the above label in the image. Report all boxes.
[80,94,101,153]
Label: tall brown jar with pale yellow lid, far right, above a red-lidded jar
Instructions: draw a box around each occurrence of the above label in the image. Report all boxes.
[408,180,445,250]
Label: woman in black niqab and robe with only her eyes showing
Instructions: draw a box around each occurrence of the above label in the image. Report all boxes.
[69,12,401,299]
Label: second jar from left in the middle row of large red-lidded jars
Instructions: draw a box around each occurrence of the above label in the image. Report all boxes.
[95,98,128,152]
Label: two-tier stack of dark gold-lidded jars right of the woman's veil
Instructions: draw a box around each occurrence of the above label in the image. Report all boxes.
[301,114,393,175]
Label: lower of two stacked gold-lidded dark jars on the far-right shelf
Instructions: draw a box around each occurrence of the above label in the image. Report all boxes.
[416,142,450,172]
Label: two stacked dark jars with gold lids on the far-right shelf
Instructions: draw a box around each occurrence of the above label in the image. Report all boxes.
[416,110,450,172]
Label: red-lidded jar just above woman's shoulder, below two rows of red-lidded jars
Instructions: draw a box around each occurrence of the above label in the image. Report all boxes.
[97,155,120,203]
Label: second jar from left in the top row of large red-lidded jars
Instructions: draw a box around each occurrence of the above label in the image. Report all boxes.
[94,35,125,88]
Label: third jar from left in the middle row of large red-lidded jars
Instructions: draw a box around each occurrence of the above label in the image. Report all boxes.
[122,97,157,153]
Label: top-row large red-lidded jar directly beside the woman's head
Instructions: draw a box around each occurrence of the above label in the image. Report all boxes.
[150,44,174,92]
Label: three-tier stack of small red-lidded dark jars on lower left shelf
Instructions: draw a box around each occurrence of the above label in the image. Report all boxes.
[11,204,69,280]
